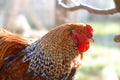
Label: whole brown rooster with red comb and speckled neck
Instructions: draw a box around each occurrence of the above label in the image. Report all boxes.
[0,23,93,80]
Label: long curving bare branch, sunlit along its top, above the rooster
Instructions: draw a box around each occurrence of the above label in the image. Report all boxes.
[57,0,120,15]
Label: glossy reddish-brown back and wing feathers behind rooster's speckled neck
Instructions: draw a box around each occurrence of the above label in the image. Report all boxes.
[0,29,29,80]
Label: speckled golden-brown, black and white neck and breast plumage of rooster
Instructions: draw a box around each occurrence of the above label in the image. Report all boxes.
[23,24,82,80]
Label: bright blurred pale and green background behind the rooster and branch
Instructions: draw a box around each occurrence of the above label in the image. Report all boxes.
[0,0,120,80]
